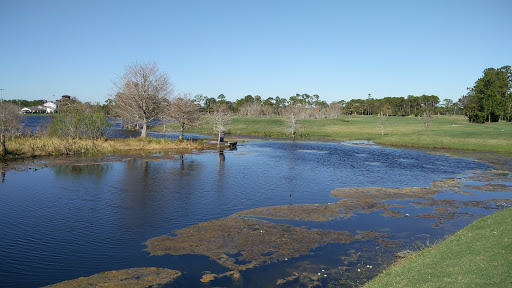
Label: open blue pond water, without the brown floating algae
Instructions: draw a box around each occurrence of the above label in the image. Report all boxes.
[0,142,512,287]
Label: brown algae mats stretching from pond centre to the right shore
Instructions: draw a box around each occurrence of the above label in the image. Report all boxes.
[142,172,512,287]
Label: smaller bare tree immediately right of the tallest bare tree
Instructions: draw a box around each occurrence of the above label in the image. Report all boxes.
[164,93,201,140]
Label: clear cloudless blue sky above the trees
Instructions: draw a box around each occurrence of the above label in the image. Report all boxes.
[0,0,512,103]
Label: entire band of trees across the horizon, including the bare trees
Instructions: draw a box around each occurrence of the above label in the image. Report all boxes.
[6,63,506,144]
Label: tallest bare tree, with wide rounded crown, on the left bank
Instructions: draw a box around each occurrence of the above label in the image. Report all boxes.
[113,63,173,137]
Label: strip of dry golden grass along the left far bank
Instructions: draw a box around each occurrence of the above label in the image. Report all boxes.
[0,137,205,159]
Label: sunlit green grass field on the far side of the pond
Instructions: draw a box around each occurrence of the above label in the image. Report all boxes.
[155,116,512,153]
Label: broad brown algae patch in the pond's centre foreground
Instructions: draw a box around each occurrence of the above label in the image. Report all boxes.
[146,216,355,270]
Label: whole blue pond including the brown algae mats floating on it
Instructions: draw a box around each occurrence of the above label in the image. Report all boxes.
[0,141,512,287]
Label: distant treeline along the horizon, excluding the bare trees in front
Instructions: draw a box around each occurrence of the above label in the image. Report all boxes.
[8,66,512,123]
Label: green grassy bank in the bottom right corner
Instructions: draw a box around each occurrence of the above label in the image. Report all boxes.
[365,208,512,288]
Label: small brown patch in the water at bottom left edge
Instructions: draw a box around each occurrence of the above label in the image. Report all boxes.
[46,267,181,288]
